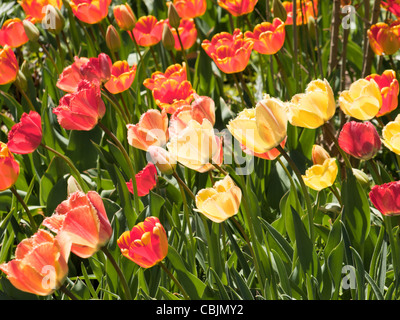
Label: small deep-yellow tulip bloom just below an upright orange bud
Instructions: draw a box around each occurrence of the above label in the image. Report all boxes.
[302,158,338,191]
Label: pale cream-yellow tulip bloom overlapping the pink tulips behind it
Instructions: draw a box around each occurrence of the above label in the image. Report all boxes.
[167,119,223,172]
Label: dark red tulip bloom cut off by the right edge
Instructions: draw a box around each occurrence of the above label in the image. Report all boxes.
[369,181,400,216]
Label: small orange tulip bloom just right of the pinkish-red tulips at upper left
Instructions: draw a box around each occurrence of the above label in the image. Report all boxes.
[104,61,136,94]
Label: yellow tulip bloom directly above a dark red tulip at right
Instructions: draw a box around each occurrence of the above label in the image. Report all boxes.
[339,79,382,121]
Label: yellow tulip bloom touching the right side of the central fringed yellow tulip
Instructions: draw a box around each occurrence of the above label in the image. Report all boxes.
[287,79,336,129]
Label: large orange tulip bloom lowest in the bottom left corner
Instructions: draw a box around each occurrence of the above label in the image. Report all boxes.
[0,229,71,296]
